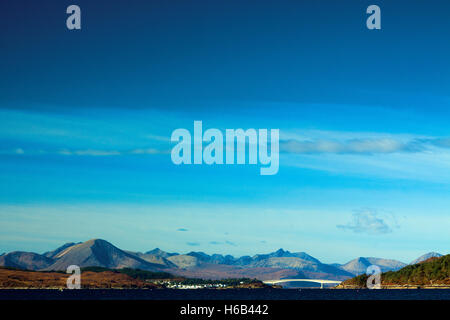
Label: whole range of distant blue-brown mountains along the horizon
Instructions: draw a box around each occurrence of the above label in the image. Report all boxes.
[0,239,440,280]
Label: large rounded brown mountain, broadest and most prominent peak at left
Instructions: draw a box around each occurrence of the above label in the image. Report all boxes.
[44,239,162,271]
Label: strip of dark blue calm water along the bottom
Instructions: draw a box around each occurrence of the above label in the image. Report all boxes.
[0,289,450,300]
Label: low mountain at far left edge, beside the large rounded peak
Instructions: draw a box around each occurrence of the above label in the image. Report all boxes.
[0,251,54,270]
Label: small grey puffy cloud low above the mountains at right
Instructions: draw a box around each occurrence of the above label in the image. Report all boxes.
[337,209,396,235]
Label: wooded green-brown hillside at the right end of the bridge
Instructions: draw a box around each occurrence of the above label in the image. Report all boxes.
[341,255,450,288]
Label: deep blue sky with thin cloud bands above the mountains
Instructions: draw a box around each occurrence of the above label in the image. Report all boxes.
[0,0,450,263]
